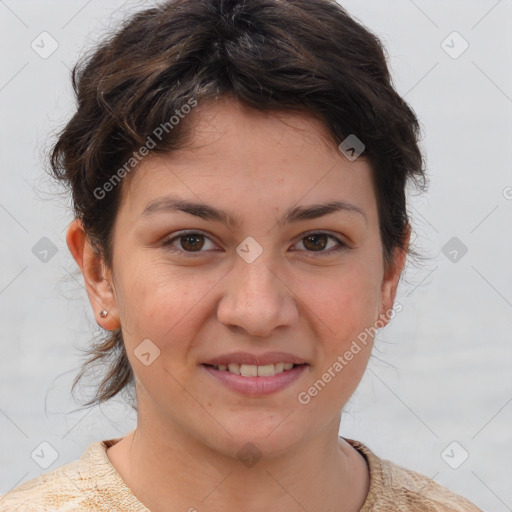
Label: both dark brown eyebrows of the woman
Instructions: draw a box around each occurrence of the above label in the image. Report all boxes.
[140,196,368,228]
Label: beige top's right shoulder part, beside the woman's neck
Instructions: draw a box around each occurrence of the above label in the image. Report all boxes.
[345,438,482,512]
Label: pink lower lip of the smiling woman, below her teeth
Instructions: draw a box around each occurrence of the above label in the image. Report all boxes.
[201,364,308,396]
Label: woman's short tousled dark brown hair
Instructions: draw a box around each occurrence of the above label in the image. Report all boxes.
[50,0,426,408]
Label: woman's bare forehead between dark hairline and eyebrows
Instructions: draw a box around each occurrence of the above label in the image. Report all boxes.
[122,98,373,221]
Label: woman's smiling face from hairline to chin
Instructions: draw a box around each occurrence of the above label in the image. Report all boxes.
[74,99,403,455]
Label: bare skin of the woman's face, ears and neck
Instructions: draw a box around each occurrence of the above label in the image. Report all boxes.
[67,98,408,512]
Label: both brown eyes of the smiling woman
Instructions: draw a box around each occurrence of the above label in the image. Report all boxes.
[164,232,347,254]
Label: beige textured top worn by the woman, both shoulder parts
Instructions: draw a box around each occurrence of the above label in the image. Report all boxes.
[0,438,482,512]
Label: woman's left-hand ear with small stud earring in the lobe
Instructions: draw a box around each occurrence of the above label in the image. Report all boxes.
[66,219,121,331]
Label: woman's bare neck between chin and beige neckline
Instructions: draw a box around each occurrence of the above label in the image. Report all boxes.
[107,412,369,512]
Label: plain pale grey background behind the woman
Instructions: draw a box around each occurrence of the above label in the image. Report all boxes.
[0,0,512,512]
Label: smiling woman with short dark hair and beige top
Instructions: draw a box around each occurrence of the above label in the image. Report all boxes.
[1,0,479,512]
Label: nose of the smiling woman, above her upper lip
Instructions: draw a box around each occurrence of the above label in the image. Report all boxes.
[217,258,299,337]
